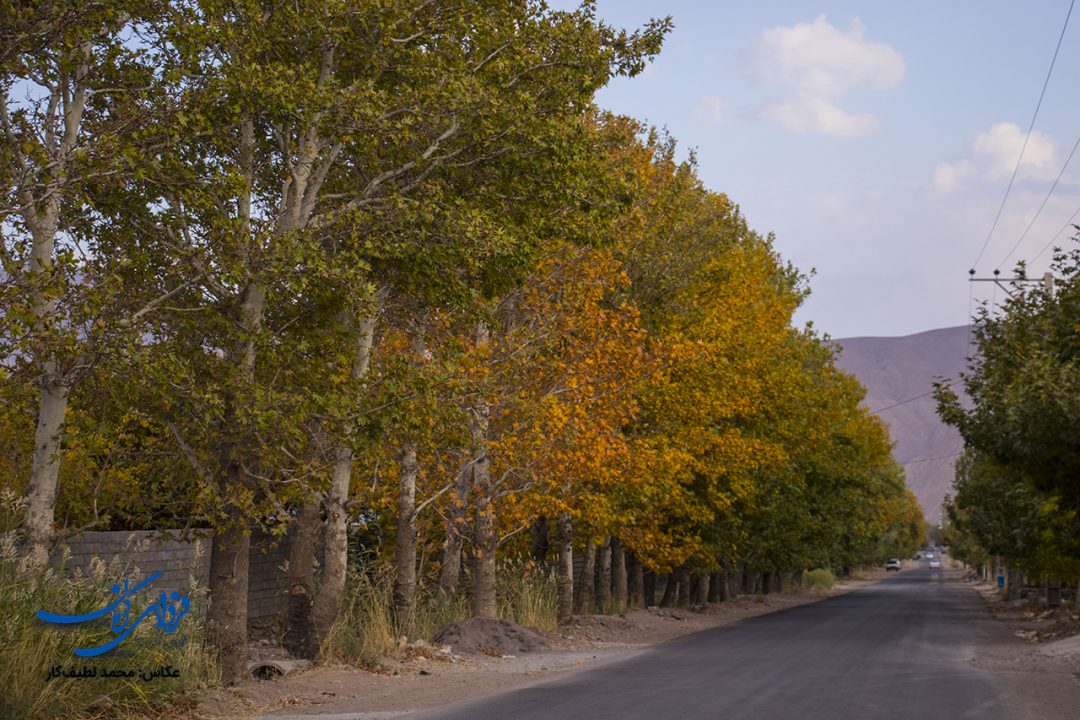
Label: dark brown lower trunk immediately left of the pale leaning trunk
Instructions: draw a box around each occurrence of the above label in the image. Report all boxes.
[282,500,321,660]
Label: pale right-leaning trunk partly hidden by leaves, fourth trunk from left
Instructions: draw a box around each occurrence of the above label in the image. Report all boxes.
[312,287,389,643]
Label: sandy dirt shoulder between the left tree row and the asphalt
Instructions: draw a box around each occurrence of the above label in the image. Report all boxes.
[197,571,885,720]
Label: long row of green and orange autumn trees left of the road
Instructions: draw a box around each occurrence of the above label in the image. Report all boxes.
[0,0,923,681]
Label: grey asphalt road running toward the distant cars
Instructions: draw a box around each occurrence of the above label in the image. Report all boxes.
[408,562,1019,720]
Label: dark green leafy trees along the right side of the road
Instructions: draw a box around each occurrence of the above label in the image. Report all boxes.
[937,249,1080,581]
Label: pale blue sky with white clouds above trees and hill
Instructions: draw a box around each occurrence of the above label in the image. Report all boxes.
[550,0,1080,338]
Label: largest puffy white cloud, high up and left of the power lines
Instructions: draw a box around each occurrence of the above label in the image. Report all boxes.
[741,15,905,137]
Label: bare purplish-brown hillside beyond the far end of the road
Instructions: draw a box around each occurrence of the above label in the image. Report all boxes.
[836,326,969,524]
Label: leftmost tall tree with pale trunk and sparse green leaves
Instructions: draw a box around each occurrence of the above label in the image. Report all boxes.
[0,1,183,567]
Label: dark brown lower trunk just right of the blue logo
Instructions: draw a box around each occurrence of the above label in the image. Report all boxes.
[206,524,251,684]
